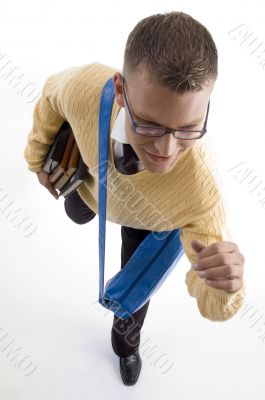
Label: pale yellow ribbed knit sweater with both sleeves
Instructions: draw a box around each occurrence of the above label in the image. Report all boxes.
[24,62,245,321]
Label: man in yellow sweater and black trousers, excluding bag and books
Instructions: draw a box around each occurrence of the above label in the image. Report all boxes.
[24,12,245,385]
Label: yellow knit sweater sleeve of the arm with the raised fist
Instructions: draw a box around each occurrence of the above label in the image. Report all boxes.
[180,198,245,321]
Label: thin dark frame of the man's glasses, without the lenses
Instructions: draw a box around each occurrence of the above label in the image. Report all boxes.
[122,76,210,140]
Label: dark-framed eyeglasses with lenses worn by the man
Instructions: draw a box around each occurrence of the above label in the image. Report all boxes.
[122,77,210,140]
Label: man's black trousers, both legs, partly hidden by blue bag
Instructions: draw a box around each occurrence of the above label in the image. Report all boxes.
[64,190,151,357]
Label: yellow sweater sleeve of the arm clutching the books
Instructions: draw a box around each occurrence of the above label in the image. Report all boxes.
[24,66,83,172]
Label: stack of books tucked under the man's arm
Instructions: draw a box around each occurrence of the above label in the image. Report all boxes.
[42,121,88,197]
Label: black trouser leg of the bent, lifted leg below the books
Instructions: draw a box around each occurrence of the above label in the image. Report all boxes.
[64,190,96,224]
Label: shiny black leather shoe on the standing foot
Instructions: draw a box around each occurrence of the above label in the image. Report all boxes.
[120,350,142,386]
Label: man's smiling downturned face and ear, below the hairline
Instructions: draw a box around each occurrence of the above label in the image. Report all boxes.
[113,68,215,174]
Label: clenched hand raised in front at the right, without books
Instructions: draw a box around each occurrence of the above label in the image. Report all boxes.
[191,240,245,293]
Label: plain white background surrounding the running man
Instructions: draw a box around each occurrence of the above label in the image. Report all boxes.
[0,0,265,400]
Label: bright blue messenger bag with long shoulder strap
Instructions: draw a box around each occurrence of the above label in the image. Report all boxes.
[98,78,184,319]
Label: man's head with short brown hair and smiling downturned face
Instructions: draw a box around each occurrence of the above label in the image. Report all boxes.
[113,12,218,174]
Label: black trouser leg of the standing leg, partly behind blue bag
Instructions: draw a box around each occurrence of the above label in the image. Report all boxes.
[111,226,151,357]
